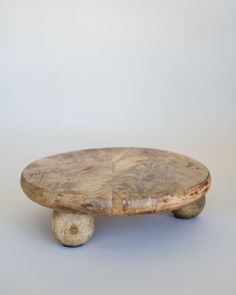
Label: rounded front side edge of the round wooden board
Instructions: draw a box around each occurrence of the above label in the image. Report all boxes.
[20,170,211,216]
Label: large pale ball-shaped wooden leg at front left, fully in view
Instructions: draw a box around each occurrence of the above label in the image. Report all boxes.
[52,210,94,247]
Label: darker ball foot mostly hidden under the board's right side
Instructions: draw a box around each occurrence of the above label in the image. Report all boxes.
[173,196,206,219]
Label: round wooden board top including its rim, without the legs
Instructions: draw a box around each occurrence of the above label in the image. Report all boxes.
[21,148,211,215]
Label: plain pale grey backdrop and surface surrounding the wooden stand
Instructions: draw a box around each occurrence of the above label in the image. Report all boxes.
[0,0,236,295]
